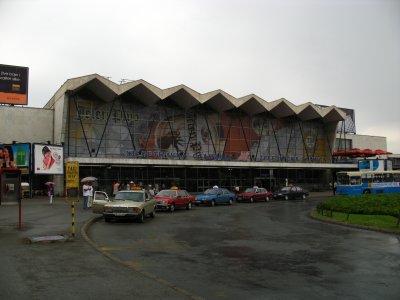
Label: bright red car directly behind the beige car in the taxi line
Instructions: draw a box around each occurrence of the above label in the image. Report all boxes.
[154,190,195,212]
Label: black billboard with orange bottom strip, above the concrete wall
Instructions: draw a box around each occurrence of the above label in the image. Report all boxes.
[0,64,29,105]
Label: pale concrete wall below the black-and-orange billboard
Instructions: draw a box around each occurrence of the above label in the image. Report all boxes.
[0,105,54,144]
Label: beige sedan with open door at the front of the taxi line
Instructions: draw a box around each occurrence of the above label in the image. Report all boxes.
[92,189,156,223]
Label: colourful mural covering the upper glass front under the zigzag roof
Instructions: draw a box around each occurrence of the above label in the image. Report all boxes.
[65,98,330,162]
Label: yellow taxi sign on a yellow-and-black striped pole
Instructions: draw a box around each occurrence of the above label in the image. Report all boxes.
[65,161,79,239]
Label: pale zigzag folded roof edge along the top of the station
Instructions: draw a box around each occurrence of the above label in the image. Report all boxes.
[45,74,346,123]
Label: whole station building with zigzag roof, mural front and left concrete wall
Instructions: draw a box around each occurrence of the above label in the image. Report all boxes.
[0,74,388,193]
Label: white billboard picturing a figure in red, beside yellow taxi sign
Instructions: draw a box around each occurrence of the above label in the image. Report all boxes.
[33,144,64,175]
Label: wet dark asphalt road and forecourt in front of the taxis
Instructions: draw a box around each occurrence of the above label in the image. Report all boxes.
[0,194,400,299]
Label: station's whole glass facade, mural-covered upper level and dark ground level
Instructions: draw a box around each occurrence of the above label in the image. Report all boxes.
[64,96,338,192]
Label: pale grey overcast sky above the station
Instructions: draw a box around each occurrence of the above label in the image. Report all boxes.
[0,0,400,153]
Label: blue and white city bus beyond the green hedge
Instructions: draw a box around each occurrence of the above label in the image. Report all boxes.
[336,171,400,195]
